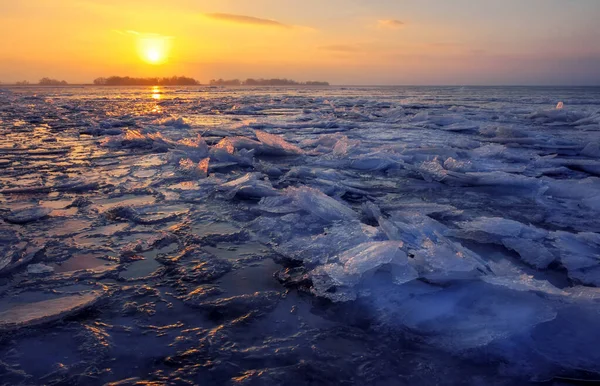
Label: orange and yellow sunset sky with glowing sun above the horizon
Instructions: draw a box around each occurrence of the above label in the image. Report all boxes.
[0,0,600,85]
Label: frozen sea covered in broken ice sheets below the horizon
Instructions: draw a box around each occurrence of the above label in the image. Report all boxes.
[0,87,600,385]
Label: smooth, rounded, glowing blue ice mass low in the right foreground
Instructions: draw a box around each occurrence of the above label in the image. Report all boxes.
[396,282,556,352]
